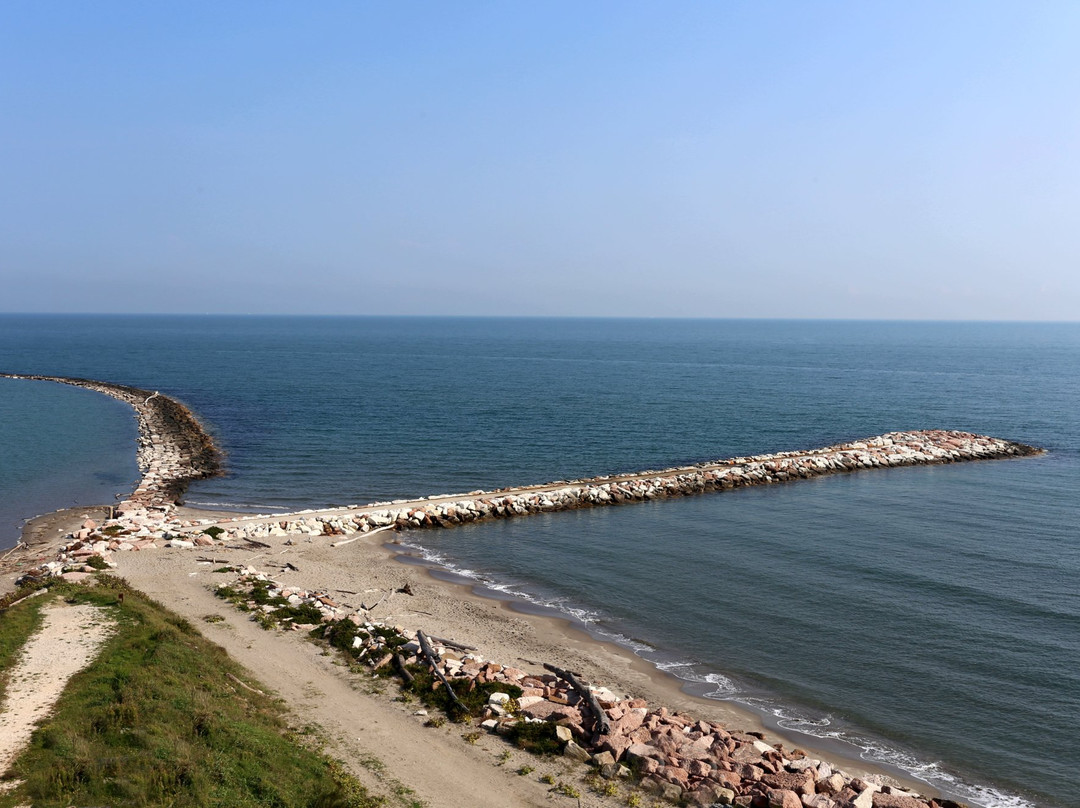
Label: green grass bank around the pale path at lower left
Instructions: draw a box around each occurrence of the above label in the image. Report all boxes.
[0,577,382,808]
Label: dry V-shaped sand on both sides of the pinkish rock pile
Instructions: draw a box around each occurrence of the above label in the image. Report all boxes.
[117,524,926,807]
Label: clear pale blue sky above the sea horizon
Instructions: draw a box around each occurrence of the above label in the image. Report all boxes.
[0,0,1080,320]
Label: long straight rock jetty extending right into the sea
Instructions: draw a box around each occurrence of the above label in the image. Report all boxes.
[203,430,1040,539]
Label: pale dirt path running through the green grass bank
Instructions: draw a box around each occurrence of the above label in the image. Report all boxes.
[0,602,116,771]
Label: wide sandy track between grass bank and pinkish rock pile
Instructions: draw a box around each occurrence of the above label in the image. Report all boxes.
[121,551,599,808]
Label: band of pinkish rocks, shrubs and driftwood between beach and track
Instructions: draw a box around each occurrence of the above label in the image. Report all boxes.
[219,566,958,808]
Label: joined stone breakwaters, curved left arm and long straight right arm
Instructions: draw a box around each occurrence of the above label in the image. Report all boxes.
[0,374,1042,573]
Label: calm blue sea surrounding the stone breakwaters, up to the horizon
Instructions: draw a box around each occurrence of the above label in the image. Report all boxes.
[0,315,1080,808]
